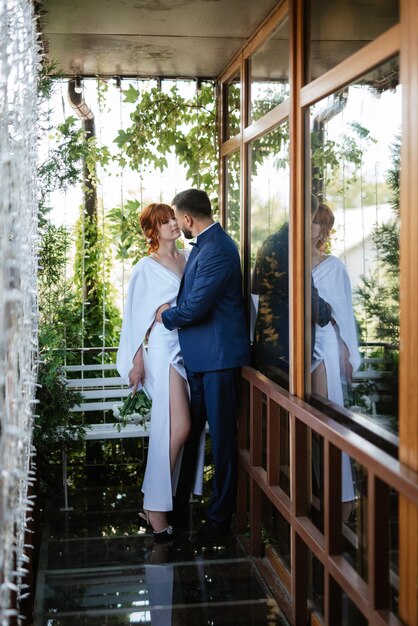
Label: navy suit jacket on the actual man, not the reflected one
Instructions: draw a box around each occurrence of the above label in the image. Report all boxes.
[162,224,250,372]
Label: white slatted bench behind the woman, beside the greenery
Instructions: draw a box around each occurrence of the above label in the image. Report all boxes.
[61,363,149,511]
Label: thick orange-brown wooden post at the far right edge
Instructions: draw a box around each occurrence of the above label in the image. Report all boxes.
[399,0,418,626]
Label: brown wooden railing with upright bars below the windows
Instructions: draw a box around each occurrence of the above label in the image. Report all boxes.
[237,367,418,626]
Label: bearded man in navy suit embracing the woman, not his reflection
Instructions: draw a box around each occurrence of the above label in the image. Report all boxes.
[157,189,250,542]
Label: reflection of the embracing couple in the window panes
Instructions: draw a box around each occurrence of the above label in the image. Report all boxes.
[252,194,360,520]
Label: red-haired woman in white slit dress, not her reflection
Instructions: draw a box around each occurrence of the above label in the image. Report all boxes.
[117,203,203,540]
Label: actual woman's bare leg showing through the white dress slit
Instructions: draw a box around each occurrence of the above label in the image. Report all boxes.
[148,366,190,532]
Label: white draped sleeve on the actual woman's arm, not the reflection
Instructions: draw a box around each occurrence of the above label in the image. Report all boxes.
[116,257,178,391]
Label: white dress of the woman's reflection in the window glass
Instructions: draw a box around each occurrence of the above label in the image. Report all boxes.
[312,255,360,502]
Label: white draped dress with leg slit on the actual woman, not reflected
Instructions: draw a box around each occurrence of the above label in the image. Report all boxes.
[116,251,204,511]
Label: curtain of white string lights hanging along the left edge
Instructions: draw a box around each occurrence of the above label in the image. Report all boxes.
[0,0,40,626]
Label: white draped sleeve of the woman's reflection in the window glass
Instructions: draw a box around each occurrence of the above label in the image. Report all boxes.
[312,255,361,372]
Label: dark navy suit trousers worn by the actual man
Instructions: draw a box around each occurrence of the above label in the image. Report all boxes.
[174,368,239,529]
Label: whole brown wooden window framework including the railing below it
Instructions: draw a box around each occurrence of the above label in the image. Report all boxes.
[219,0,418,626]
